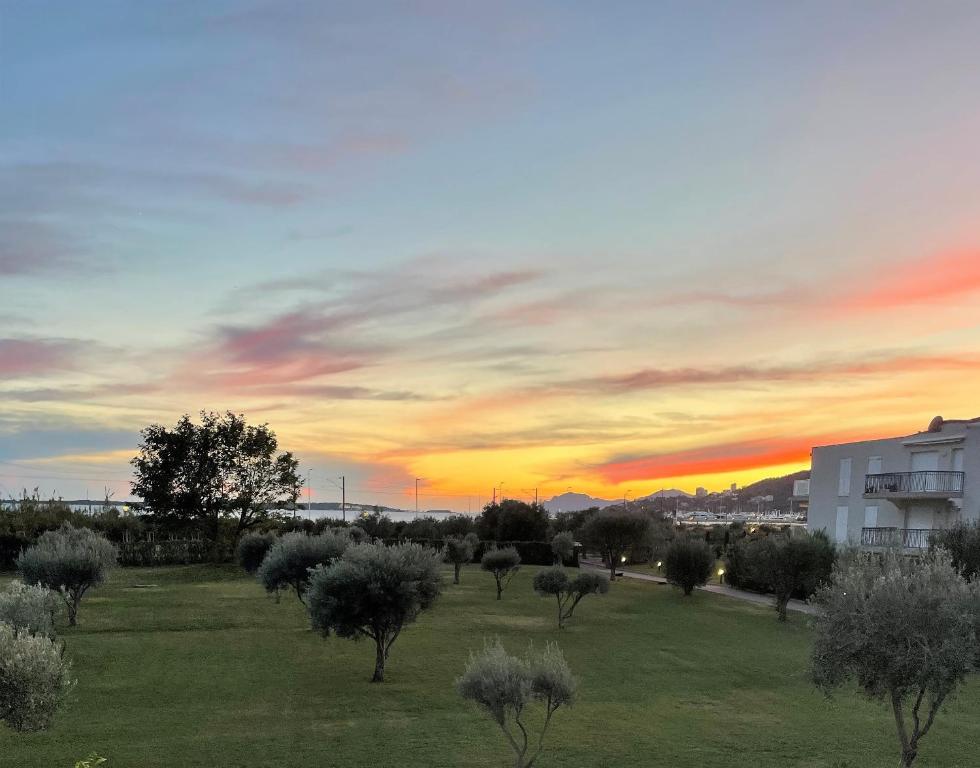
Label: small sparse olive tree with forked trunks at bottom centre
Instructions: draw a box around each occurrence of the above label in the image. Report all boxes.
[456,640,575,768]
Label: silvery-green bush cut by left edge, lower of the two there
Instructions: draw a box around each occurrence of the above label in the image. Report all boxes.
[0,622,71,731]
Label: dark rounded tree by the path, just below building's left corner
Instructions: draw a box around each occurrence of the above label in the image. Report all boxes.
[745,531,834,621]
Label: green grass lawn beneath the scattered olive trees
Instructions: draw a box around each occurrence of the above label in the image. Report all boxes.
[0,566,980,768]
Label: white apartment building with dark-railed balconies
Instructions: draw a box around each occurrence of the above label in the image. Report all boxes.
[807,416,980,549]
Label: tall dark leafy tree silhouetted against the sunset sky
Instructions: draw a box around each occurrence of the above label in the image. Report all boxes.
[132,411,302,544]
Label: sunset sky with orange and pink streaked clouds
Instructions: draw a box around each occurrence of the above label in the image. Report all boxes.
[0,0,980,512]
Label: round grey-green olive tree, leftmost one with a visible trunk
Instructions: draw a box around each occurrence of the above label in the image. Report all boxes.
[17,523,117,626]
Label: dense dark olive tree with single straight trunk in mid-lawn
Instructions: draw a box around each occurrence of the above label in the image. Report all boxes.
[307,542,442,683]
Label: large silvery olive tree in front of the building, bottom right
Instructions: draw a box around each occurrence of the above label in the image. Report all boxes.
[812,550,980,767]
